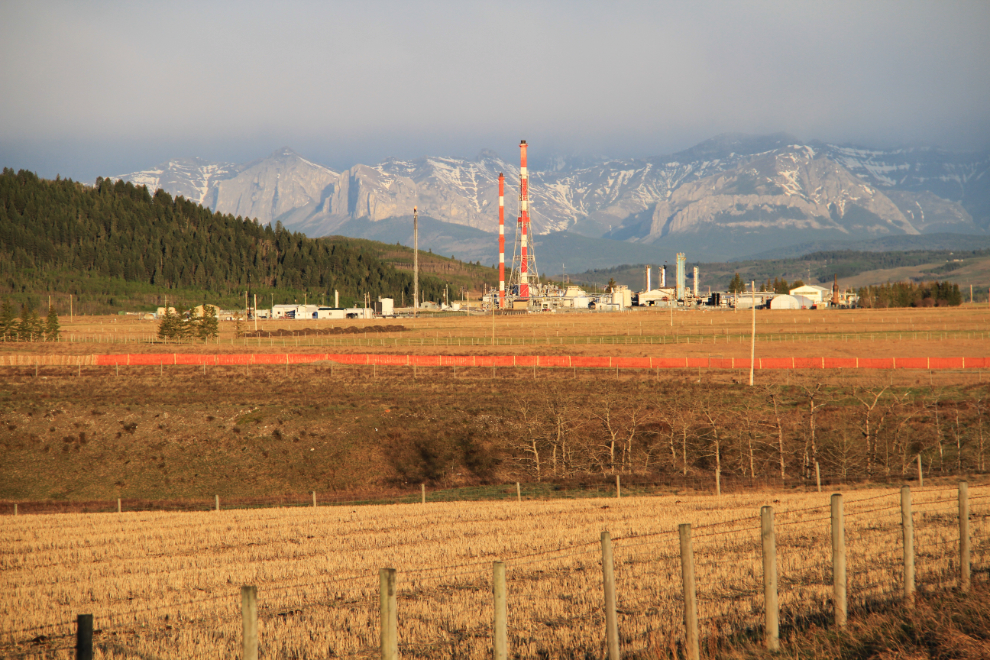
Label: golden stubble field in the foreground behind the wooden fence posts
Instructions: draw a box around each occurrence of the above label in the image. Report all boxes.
[0,481,990,658]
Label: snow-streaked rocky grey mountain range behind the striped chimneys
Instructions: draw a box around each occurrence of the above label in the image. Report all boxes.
[112,134,990,260]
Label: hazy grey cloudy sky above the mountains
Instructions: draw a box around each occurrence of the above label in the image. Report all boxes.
[0,0,990,181]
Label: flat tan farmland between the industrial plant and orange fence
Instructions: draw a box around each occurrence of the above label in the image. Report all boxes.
[0,305,990,357]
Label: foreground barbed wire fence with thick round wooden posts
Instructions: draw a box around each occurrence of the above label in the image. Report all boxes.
[0,482,990,660]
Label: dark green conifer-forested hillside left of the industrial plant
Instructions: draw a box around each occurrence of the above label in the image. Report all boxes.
[0,168,445,311]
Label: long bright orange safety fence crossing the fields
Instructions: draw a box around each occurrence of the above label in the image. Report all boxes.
[0,353,990,370]
